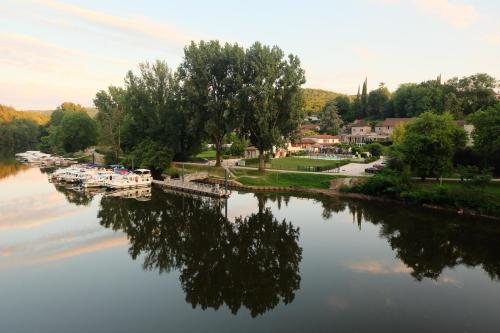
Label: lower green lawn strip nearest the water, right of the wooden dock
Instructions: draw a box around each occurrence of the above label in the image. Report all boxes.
[233,170,338,189]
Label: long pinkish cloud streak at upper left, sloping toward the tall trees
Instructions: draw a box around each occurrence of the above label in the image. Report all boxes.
[35,0,194,45]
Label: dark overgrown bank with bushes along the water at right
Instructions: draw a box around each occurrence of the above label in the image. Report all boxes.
[341,172,500,217]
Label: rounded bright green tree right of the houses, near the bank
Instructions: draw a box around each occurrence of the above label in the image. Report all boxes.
[397,112,467,179]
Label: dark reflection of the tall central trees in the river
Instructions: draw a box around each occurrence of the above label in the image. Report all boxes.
[98,189,302,317]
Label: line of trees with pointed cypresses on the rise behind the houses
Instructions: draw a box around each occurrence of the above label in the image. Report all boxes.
[323,73,497,122]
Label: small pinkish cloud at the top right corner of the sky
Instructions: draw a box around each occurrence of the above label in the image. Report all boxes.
[415,0,479,28]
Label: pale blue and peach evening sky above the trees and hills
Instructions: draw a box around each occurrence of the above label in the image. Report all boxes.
[0,0,500,110]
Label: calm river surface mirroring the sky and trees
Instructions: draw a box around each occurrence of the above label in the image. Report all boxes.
[0,167,500,332]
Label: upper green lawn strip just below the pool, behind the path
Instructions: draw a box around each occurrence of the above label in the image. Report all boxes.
[247,157,350,171]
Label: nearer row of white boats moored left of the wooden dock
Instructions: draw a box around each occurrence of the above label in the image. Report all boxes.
[49,164,153,189]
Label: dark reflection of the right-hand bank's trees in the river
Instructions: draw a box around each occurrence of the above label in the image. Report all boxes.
[319,199,500,281]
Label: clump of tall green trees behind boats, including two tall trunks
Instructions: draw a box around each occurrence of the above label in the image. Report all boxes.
[94,41,305,169]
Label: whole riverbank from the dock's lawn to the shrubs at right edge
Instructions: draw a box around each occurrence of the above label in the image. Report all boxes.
[167,165,500,220]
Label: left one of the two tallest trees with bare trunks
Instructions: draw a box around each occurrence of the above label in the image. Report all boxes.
[179,41,245,166]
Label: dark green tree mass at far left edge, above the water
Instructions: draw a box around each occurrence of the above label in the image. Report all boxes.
[0,119,39,158]
